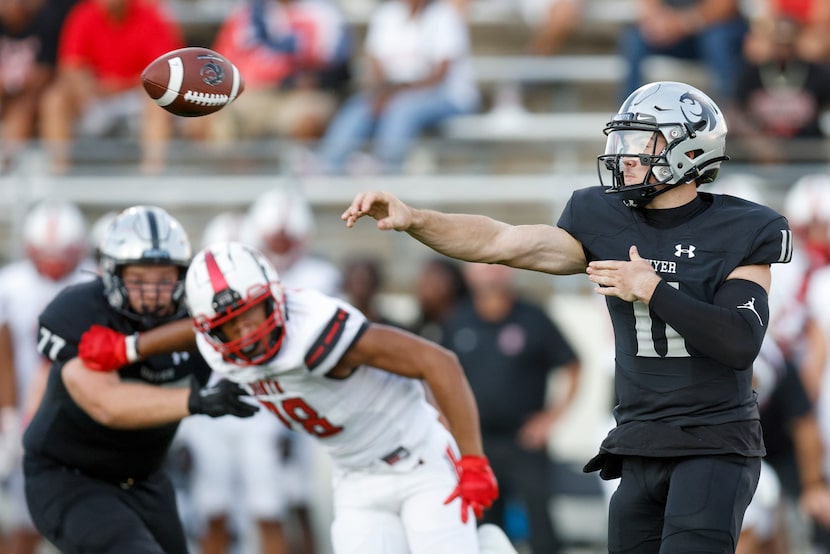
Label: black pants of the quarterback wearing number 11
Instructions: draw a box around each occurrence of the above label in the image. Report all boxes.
[608,455,761,554]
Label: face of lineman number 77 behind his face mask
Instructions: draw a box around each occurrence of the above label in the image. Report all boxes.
[121,265,179,316]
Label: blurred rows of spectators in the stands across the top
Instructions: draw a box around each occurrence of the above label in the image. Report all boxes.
[0,0,830,174]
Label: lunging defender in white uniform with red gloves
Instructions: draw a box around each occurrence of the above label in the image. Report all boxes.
[186,242,498,554]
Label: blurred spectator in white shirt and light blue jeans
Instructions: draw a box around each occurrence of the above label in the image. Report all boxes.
[320,0,478,173]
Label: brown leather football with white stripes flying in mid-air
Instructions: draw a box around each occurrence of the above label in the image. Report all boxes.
[141,46,245,117]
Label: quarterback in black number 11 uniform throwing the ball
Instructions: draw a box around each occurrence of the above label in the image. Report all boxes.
[342,82,792,554]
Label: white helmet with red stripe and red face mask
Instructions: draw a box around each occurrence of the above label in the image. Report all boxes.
[185,242,285,366]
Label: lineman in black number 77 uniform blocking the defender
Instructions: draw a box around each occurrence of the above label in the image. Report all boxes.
[23,206,256,554]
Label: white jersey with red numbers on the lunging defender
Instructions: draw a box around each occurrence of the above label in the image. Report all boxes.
[197,289,438,470]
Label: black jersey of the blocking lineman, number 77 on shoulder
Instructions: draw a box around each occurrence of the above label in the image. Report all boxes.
[23,278,210,481]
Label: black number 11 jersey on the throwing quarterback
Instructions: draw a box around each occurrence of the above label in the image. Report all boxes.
[558,187,792,456]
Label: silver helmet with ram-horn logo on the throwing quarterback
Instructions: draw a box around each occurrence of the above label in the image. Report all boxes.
[597,81,729,208]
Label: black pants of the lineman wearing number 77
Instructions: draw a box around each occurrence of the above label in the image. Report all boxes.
[24,452,187,554]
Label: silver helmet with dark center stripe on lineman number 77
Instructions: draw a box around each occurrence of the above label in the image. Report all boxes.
[99,206,191,328]
